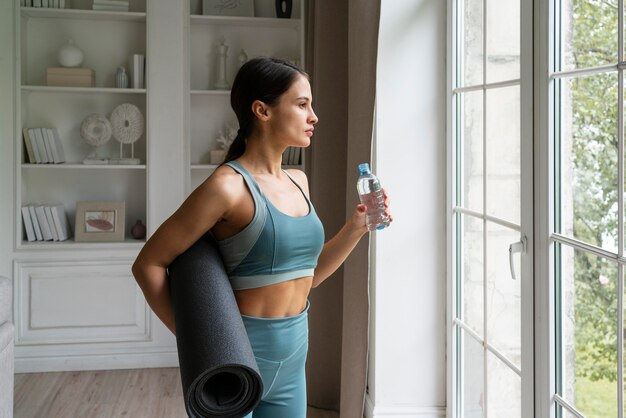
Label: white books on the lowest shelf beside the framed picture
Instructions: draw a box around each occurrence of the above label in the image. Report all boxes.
[22,204,72,242]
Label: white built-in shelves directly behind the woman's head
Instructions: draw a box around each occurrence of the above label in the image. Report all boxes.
[189,0,305,190]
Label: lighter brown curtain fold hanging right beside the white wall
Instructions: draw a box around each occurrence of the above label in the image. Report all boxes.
[340,0,380,418]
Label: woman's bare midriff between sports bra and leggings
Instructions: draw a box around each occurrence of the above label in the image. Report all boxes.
[234,277,313,318]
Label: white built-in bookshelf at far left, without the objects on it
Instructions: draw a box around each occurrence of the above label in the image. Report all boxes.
[15,0,148,251]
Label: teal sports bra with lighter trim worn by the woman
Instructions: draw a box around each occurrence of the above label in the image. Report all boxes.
[217,161,324,290]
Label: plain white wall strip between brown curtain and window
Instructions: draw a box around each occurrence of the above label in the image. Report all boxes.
[366,0,446,418]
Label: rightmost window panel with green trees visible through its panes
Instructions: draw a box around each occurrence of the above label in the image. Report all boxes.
[542,0,626,418]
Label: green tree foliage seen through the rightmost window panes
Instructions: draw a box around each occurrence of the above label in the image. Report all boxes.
[563,0,622,381]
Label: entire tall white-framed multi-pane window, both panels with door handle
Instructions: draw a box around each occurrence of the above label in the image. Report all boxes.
[448,0,626,418]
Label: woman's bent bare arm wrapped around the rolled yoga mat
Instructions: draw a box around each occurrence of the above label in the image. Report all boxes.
[132,172,236,334]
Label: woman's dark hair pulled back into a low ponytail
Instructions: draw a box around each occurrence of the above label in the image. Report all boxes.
[222,57,309,164]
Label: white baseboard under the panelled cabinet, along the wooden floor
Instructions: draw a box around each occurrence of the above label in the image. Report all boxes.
[15,352,178,373]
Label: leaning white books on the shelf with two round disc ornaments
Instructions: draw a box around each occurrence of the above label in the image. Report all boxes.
[22,128,65,164]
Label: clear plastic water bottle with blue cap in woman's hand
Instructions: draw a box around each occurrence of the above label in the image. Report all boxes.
[356,163,389,231]
